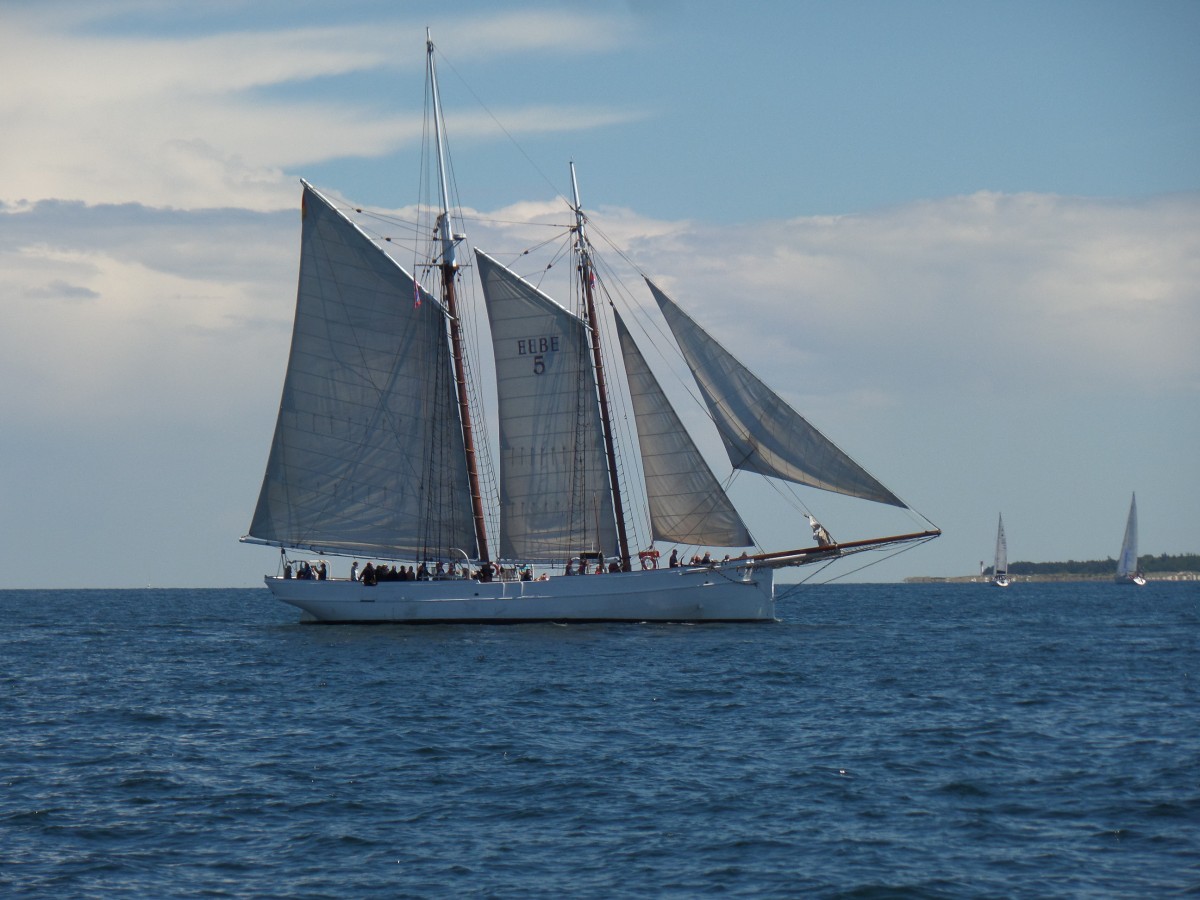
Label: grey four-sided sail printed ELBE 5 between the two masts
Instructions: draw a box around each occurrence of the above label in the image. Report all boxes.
[475,250,617,560]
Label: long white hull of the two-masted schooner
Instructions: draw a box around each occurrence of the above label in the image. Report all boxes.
[266,563,775,623]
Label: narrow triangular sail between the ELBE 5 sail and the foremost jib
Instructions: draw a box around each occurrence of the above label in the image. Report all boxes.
[616,314,752,547]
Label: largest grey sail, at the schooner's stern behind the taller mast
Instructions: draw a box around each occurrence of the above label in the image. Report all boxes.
[248,184,476,557]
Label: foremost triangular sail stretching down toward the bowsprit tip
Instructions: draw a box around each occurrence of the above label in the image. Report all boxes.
[646,278,906,508]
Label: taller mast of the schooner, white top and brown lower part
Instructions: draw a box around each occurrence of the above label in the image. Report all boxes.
[425,29,491,563]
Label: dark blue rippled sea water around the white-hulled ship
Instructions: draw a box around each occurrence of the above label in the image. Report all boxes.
[0,583,1200,898]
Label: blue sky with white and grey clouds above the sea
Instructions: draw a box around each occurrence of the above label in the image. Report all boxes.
[0,0,1200,588]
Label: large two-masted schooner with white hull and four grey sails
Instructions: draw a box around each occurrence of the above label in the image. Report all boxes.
[242,35,941,623]
